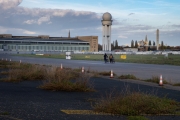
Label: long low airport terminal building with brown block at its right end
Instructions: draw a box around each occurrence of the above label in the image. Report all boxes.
[0,34,98,52]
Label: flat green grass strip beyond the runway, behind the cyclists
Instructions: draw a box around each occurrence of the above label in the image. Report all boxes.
[17,54,180,66]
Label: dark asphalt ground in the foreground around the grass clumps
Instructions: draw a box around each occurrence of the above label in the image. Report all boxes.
[0,78,180,120]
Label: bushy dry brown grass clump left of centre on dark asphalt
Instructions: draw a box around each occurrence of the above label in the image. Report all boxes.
[39,68,94,92]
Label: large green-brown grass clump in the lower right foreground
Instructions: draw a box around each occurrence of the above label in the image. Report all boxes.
[94,89,180,116]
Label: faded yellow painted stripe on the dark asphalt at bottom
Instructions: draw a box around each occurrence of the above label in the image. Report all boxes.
[61,110,112,115]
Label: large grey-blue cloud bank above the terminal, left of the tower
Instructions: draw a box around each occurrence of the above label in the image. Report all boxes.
[0,4,101,36]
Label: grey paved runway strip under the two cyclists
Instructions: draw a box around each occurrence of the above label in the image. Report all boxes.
[0,54,180,83]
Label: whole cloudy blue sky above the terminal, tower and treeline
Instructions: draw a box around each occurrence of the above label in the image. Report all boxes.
[0,0,180,46]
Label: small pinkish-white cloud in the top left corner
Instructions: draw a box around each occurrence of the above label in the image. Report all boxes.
[0,0,22,10]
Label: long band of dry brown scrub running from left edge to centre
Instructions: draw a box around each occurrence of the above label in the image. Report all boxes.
[0,61,94,92]
